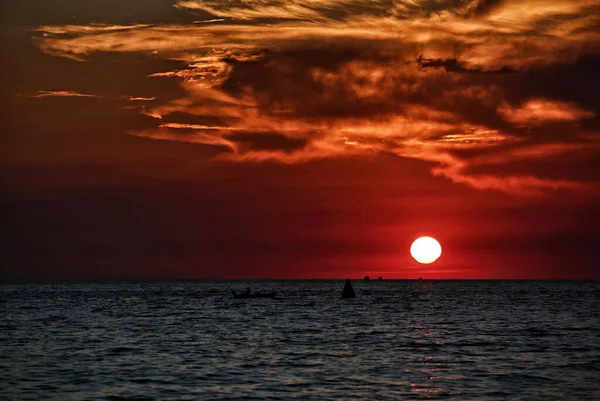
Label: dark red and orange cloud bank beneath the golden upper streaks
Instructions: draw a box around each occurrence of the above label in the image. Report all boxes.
[111,39,600,193]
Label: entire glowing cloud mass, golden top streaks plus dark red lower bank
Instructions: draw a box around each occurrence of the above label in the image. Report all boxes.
[29,0,600,195]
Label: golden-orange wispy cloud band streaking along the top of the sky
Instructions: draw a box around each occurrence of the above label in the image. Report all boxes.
[35,0,600,71]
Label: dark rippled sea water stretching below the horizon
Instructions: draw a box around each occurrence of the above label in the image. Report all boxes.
[0,281,600,400]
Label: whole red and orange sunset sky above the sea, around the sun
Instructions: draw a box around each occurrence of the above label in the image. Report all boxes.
[0,0,600,280]
